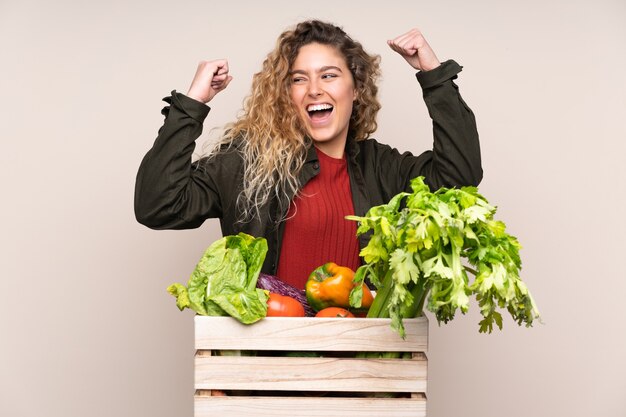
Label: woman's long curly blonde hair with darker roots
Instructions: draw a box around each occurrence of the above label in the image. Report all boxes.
[212,20,380,221]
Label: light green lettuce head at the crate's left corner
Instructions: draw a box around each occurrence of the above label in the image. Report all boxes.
[167,233,267,324]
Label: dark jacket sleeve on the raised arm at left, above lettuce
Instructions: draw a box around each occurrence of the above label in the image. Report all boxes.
[135,91,221,229]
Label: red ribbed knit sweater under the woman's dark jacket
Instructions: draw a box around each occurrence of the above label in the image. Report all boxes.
[276,150,360,289]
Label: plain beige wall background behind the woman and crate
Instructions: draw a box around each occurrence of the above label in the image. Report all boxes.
[0,0,626,417]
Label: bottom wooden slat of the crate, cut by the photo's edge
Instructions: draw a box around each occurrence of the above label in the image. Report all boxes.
[194,396,426,417]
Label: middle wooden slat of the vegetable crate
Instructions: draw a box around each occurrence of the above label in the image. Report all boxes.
[195,356,427,392]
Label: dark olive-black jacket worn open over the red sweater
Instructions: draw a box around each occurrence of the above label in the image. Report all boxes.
[135,61,482,274]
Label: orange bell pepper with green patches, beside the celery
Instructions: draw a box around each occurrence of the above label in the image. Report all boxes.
[305,262,374,311]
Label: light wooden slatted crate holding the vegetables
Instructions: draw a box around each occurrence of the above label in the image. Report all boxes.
[194,316,428,417]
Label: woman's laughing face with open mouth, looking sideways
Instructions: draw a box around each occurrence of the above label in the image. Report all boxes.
[291,43,356,158]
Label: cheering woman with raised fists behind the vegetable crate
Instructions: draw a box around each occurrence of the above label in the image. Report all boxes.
[135,21,482,288]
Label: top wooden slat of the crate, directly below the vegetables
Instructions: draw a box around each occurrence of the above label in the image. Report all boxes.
[195,316,428,352]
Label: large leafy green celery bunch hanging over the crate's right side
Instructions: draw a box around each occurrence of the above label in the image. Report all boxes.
[347,177,540,337]
